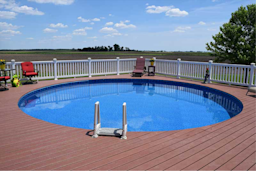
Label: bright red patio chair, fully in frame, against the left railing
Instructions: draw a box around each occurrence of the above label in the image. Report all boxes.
[21,62,39,83]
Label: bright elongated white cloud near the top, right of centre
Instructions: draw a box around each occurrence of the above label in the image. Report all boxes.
[146,5,188,17]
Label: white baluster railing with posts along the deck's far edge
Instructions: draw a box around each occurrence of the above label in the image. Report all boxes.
[6,57,256,86]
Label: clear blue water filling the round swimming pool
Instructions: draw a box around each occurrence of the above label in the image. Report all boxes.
[18,79,243,131]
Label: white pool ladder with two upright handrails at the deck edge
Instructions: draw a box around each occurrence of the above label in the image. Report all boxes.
[92,102,127,140]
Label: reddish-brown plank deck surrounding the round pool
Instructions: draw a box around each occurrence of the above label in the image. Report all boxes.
[0,75,256,170]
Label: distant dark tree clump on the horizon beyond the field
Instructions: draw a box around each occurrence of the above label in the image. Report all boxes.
[77,44,136,51]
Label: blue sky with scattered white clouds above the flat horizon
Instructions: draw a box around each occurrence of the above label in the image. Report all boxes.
[0,0,255,51]
